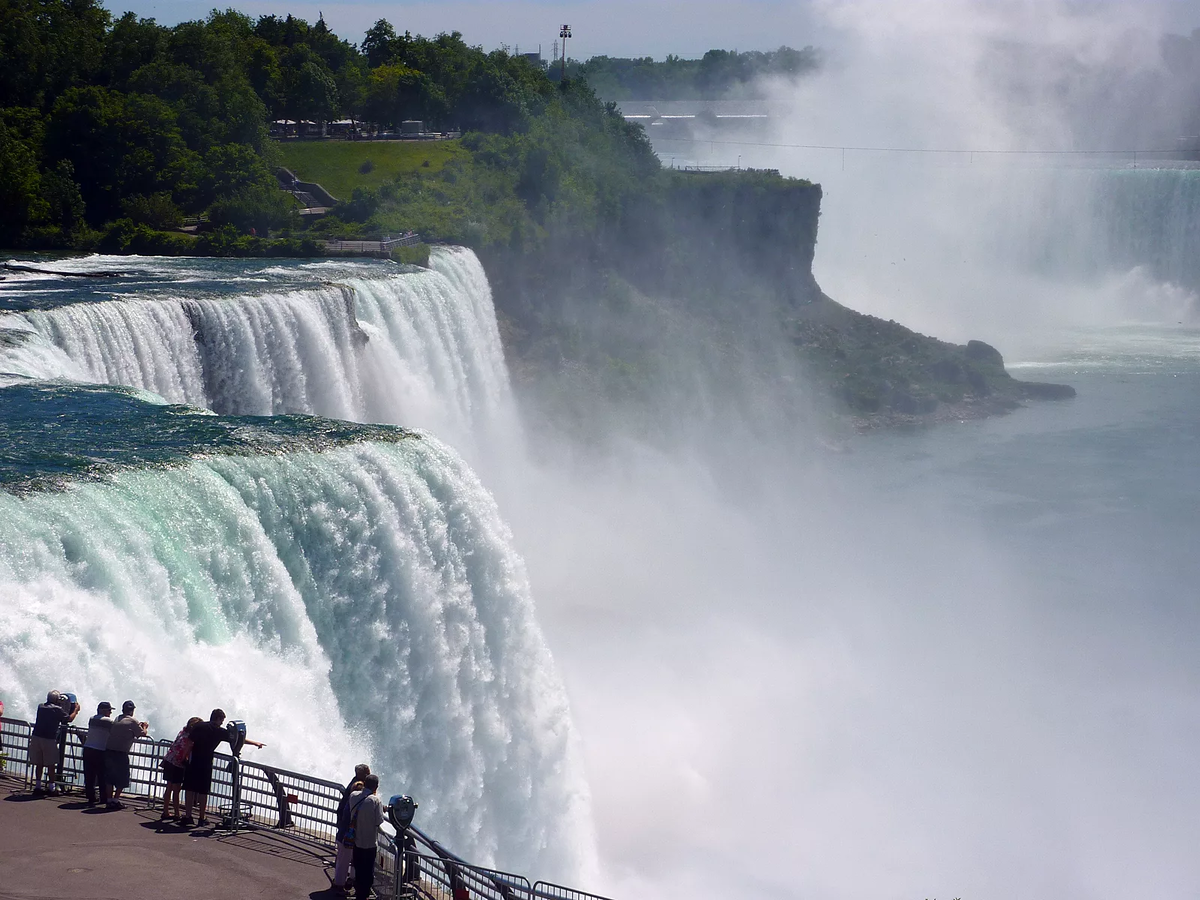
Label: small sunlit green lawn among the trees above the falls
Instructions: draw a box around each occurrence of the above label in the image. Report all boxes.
[278,140,467,200]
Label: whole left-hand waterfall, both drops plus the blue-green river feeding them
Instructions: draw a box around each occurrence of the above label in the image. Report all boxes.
[0,250,594,880]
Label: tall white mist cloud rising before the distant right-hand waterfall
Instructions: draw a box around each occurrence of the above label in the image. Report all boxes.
[713,0,1200,352]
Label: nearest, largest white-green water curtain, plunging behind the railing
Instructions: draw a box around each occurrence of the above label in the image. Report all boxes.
[0,438,594,878]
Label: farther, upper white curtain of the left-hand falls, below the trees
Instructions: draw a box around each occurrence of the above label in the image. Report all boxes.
[0,247,512,446]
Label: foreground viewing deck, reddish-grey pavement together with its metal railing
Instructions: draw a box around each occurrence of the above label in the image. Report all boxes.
[0,718,606,900]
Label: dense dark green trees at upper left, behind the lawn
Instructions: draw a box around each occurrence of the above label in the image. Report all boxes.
[0,0,557,247]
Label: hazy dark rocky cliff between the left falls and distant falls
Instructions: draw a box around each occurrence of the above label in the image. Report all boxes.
[484,172,1074,436]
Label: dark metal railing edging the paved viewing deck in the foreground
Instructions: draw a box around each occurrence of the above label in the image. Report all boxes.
[0,718,606,900]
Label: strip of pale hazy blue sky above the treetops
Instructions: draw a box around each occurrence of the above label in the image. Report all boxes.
[98,0,1200,59]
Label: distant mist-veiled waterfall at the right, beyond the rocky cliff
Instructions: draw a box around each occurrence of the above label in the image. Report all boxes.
[792,156,1200,343]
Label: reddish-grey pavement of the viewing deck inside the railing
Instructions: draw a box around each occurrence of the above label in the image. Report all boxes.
[0,776,335,900]
